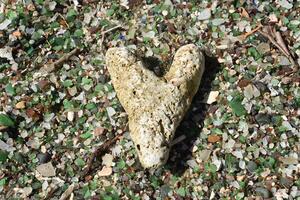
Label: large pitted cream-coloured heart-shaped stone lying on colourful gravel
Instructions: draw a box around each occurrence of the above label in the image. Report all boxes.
[106,44,204,168]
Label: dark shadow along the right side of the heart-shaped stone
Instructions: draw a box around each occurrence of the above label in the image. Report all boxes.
[165,52,220,176]
